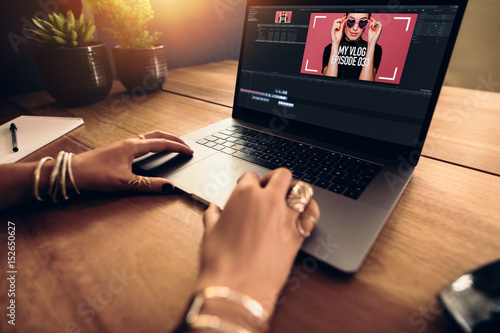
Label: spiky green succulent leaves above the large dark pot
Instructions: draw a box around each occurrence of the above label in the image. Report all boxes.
[26,10,95,47]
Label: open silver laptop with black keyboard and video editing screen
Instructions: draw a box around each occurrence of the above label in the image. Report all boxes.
[134,0,467,273]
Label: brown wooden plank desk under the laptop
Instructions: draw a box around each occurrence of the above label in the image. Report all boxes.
[0,62,500,333]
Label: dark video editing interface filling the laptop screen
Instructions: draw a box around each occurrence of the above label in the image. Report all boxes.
[236,5,458,146]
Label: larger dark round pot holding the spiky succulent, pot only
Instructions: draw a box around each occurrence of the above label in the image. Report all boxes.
[34,43,113,106]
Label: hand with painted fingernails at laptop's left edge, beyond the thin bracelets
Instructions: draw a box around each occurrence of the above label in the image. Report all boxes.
[72,131,193,192]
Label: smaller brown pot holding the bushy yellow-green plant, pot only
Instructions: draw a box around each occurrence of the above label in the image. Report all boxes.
[113,45,167,96]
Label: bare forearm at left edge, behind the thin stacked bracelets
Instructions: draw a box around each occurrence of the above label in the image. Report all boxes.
[0,160,54,209]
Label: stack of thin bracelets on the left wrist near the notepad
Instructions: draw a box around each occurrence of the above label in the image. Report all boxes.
[33,151,80,203]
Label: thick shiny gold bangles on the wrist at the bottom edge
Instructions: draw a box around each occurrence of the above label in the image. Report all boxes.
[186,286,269,333]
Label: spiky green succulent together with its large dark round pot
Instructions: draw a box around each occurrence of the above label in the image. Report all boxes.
[27,11,113,106]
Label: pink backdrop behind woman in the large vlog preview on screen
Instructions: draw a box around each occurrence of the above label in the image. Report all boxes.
[300,13,418,84]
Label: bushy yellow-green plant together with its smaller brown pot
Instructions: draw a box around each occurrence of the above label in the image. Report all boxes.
[84,0,167,95]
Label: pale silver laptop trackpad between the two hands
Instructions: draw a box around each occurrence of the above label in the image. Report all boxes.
[168,153,269,208]
